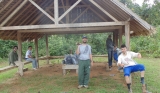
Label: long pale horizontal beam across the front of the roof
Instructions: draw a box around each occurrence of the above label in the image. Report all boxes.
[0,22,125,30]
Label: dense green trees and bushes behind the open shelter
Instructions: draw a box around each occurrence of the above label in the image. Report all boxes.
[0,0,160,58]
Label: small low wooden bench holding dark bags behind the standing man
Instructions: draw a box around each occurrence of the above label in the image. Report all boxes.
[62,64,78,75]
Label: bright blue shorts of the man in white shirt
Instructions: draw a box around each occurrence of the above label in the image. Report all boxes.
[123,64,145,76]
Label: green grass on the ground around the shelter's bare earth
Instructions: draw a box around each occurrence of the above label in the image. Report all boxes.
[0,58,160,93]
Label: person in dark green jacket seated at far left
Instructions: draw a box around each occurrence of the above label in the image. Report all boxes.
[8,46,18,66]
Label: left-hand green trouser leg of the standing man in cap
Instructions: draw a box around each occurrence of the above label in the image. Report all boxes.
[78,60,85,85]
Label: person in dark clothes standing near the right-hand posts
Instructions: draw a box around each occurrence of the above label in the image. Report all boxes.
[106,35,114,70]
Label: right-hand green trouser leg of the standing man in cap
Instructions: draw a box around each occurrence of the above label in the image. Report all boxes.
[84,60,90,87]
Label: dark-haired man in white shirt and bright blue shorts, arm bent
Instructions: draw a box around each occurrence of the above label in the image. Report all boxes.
[117,45,149,93]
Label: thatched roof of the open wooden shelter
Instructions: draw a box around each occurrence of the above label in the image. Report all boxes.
[0,0,155,41]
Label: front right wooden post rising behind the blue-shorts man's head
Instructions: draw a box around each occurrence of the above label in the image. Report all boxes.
[125,22,130,50]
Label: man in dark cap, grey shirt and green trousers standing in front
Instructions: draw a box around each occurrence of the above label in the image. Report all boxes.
[76,36,93,89]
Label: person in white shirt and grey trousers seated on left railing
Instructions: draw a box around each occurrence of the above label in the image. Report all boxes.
[25,46,37,70]
